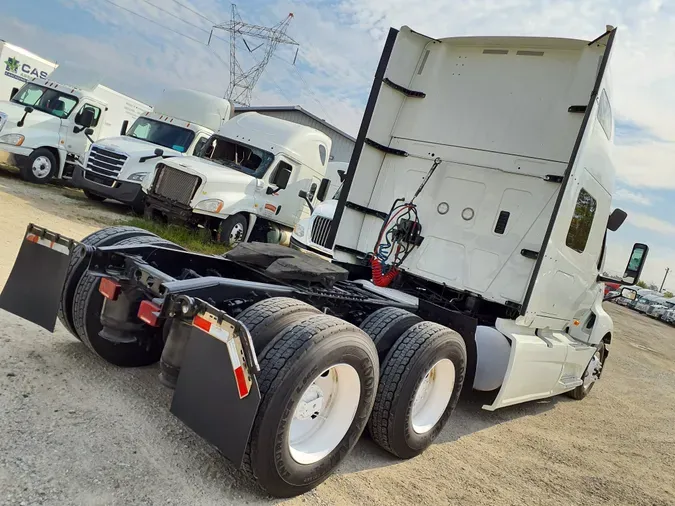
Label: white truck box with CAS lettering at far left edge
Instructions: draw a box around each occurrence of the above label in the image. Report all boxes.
[0,40,57,100]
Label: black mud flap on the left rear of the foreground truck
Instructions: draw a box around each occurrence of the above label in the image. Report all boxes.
[0,224,75,332]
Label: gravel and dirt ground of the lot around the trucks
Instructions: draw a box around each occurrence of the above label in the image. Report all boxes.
[0,170,675,506]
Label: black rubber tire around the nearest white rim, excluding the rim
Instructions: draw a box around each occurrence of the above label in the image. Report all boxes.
[244,315,379,497]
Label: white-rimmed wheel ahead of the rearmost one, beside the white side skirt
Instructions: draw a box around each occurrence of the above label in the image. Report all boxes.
[368,321,467,459]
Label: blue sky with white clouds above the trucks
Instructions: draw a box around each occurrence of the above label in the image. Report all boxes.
[0,0,675,291]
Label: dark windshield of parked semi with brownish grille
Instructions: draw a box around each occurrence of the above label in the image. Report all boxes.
[200,135,274,178]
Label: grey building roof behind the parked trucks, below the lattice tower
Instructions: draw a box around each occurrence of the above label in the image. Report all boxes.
[234,105,356,162]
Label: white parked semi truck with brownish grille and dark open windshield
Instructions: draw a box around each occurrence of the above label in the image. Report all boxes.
[143,112,331,246]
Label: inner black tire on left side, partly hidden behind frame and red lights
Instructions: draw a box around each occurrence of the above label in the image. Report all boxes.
[73,236,176,367]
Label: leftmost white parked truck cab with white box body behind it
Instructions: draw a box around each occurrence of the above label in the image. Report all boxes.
[0,64,151,183]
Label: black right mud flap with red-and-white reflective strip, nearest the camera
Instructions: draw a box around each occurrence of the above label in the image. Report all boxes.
[171,308,260,467]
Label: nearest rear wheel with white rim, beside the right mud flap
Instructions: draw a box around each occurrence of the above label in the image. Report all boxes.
[244,315,379,497]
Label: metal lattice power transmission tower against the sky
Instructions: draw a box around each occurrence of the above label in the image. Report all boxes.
[213,4,299,106]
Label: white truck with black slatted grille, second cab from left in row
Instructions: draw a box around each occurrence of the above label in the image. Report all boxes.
[72,89,234,212]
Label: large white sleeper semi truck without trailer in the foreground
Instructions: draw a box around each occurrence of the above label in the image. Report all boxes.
[0,27,648,496]
